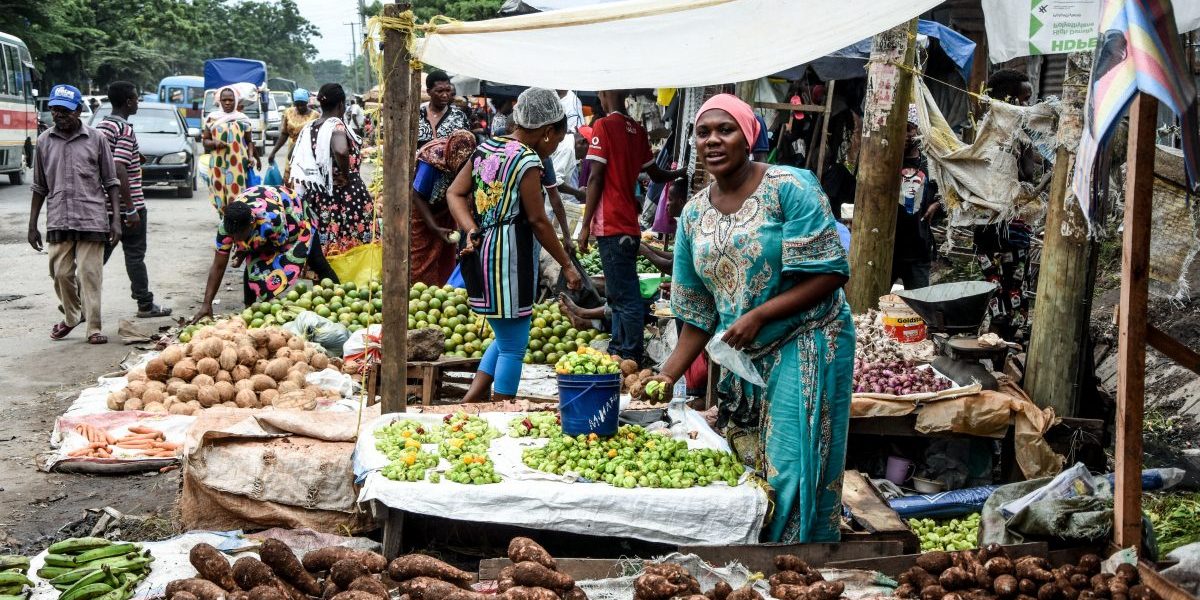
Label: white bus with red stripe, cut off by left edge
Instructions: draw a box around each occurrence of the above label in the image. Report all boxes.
[0,32,37,184]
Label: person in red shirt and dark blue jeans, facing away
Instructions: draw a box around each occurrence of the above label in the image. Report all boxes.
[580,90,683,362]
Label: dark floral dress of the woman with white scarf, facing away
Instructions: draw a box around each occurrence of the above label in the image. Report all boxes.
[305,122,374,257]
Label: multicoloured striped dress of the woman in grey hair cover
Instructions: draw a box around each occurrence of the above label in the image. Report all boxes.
[462,137,545,318]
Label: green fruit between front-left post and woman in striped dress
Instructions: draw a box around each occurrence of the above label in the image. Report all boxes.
[408,282,493,359]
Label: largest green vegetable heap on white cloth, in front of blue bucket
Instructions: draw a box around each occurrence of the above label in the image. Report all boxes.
[522,425,745,488]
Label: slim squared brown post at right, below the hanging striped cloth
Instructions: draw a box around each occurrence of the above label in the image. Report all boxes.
[1112,94,1158,547]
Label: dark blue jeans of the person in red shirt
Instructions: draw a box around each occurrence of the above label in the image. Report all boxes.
[596,235,646,362]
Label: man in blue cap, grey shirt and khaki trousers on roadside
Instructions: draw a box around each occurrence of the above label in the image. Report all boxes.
[29,85,121,344]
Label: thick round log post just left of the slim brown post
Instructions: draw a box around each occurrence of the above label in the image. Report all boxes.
[1024,53,1096,416]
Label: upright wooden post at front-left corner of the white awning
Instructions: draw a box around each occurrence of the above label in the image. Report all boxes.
[379,4,416,413]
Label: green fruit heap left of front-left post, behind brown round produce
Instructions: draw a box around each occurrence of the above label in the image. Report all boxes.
[238,278,383,341]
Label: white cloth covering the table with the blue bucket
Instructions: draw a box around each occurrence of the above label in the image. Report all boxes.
[354,409,767,545]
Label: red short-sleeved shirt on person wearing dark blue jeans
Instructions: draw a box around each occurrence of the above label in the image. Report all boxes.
[587,113,654,236]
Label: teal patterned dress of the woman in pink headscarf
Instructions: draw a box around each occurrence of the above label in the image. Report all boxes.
[671,167,854,542]
